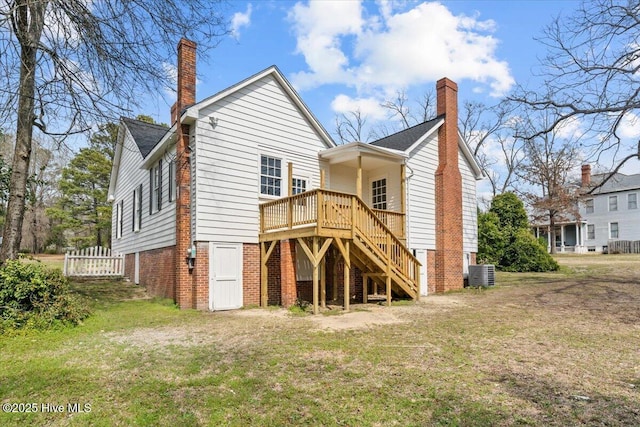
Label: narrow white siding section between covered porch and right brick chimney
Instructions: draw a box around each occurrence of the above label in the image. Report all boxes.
[407,132,438,249]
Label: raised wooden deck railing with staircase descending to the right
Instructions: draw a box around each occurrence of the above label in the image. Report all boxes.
[260,189,420,301]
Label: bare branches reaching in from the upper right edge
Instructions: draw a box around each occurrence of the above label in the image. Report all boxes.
[511,0,640,183]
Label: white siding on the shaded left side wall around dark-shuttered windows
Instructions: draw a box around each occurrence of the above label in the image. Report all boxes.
[112,125,175,253]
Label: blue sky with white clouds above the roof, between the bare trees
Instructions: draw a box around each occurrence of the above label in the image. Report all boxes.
[145,0,577,133]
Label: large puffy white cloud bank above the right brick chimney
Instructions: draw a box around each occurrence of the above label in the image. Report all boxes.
[289,1,514,96]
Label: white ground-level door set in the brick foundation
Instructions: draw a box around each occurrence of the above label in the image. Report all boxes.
[209,243,242,310]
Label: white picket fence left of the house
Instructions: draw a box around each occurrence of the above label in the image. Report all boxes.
[63,246,124,277]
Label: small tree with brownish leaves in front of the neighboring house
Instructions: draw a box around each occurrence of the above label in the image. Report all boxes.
[518,108,580,253]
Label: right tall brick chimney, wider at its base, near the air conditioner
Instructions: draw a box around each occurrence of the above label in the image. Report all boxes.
[435,78,464,292]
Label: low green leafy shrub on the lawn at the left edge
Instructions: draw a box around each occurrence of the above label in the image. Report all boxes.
[0,260,89,332]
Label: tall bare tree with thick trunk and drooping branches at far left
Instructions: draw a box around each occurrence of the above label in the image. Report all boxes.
[0,0,226,262]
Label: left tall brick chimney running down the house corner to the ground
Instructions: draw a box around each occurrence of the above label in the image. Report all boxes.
[171,38,196,308]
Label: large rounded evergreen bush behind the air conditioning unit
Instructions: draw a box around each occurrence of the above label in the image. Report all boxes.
[478,193,558,271]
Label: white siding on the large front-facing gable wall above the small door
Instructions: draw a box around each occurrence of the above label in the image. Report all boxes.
[192,75,327,243]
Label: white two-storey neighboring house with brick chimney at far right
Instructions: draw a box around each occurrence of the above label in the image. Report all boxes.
[534,165,640,253]
